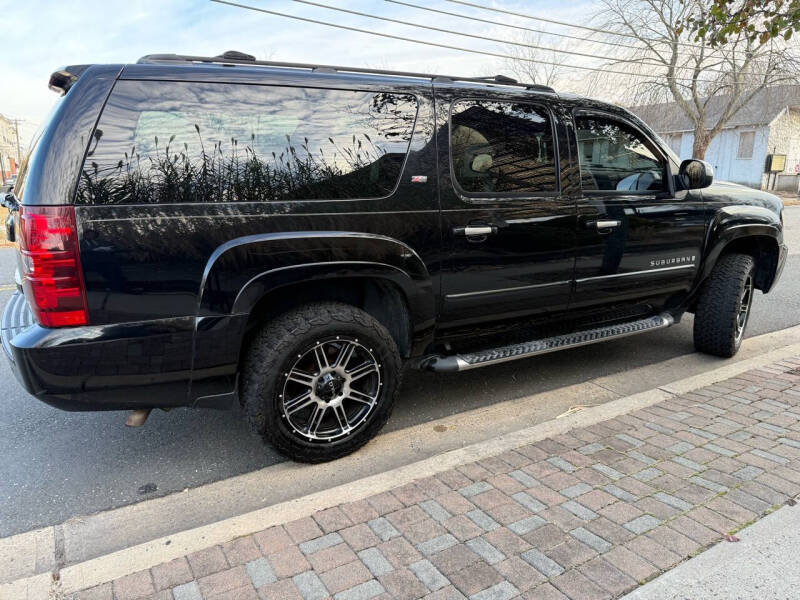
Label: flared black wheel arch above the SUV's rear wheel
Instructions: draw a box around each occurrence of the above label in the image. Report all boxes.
[198,231,435,356]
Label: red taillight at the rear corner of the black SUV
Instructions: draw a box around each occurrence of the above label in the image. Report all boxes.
[18,205,89,327]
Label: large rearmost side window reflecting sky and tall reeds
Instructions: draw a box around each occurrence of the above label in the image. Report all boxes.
[76,81,417,204]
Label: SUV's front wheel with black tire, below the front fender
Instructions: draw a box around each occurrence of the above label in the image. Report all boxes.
[694,254,755,358]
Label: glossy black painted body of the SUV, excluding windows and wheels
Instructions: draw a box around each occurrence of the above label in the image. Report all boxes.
[0,64,785,410]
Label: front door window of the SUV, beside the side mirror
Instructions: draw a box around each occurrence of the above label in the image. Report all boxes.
[575,116,666,193]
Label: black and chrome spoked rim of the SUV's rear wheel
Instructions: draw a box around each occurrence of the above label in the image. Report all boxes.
[278,336,383,443]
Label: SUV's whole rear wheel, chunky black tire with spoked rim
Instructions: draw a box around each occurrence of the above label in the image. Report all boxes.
[242,302,401,462]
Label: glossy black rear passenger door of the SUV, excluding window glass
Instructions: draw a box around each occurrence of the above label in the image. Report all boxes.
[434,82,576,326]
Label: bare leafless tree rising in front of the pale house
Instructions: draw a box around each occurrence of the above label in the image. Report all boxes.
[592,0,800,158]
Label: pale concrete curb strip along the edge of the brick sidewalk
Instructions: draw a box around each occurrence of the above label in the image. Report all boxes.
[0,344,800,600]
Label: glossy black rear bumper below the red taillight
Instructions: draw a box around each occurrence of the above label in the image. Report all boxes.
[0,292,194,410]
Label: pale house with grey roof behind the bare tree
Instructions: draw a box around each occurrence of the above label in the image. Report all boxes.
[630,86,800,191]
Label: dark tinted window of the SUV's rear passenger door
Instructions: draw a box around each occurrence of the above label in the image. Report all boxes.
[450,100,556,195]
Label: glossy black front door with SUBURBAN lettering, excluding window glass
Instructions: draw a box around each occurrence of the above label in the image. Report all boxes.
[570,106,706,310]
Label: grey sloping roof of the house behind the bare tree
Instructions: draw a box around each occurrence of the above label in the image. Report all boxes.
[629,85,800,133]
